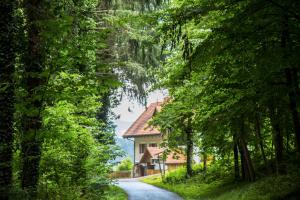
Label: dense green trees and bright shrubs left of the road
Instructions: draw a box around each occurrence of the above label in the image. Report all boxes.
[0,0,151,199]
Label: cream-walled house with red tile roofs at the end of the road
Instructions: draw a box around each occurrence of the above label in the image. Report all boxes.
[123,102,186,177]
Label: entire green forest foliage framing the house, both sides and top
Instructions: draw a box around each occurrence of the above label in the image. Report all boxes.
[0,0,300,199]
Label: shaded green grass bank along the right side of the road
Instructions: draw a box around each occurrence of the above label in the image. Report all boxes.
[141,169,300,200]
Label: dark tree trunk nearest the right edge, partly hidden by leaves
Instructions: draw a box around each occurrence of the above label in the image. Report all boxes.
[281,12,300,152]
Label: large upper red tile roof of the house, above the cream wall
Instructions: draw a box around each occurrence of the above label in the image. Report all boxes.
[123,102,163,138]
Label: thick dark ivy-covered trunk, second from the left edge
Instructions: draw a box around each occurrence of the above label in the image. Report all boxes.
[21,0,46,199]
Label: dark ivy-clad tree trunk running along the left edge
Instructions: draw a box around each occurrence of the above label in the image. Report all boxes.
[0,0,16,194]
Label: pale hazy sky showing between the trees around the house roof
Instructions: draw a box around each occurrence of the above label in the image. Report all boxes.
[113,90,167,137]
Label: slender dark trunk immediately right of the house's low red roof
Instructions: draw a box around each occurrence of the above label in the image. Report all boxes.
[186,119,193,178]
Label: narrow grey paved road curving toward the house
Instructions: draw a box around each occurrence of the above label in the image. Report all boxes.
[118,178,182,200]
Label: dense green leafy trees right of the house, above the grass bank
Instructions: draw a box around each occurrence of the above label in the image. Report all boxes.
[141,0,300,186]
